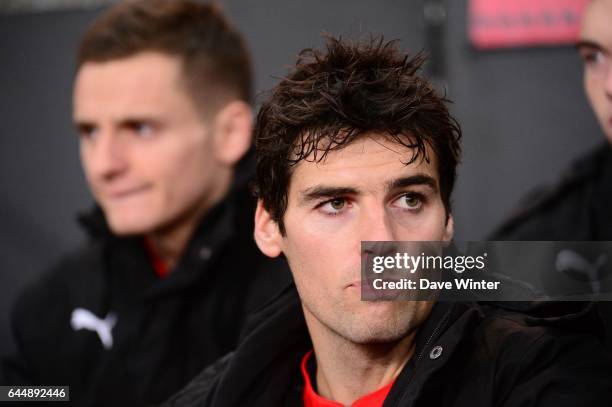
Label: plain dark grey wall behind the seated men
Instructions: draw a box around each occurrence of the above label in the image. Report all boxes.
[0,0,603,353]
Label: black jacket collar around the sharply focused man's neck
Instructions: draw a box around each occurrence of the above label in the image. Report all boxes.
[213,284,482,406]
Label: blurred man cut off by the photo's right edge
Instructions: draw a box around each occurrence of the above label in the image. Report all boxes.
[491,0,612,349]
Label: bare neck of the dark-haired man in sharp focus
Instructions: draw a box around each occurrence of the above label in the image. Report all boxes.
[307,312,416,405]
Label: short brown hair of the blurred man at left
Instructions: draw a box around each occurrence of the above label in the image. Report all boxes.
[77,0,252,109]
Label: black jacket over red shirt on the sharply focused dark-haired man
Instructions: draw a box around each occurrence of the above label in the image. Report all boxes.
[163,286,612,407]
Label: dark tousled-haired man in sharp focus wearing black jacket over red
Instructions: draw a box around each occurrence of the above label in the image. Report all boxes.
[166,38,612,407]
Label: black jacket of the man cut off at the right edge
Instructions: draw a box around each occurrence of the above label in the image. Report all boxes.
[489,142,612,351]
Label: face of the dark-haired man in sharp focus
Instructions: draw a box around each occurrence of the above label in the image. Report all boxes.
[256,134,453,344]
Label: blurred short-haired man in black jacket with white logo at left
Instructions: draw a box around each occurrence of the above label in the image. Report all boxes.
[0,0,286,406]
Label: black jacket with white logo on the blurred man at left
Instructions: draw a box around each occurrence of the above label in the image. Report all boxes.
[0,189,290,406]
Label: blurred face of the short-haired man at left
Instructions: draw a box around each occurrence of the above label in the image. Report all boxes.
[73,52,224,235]
